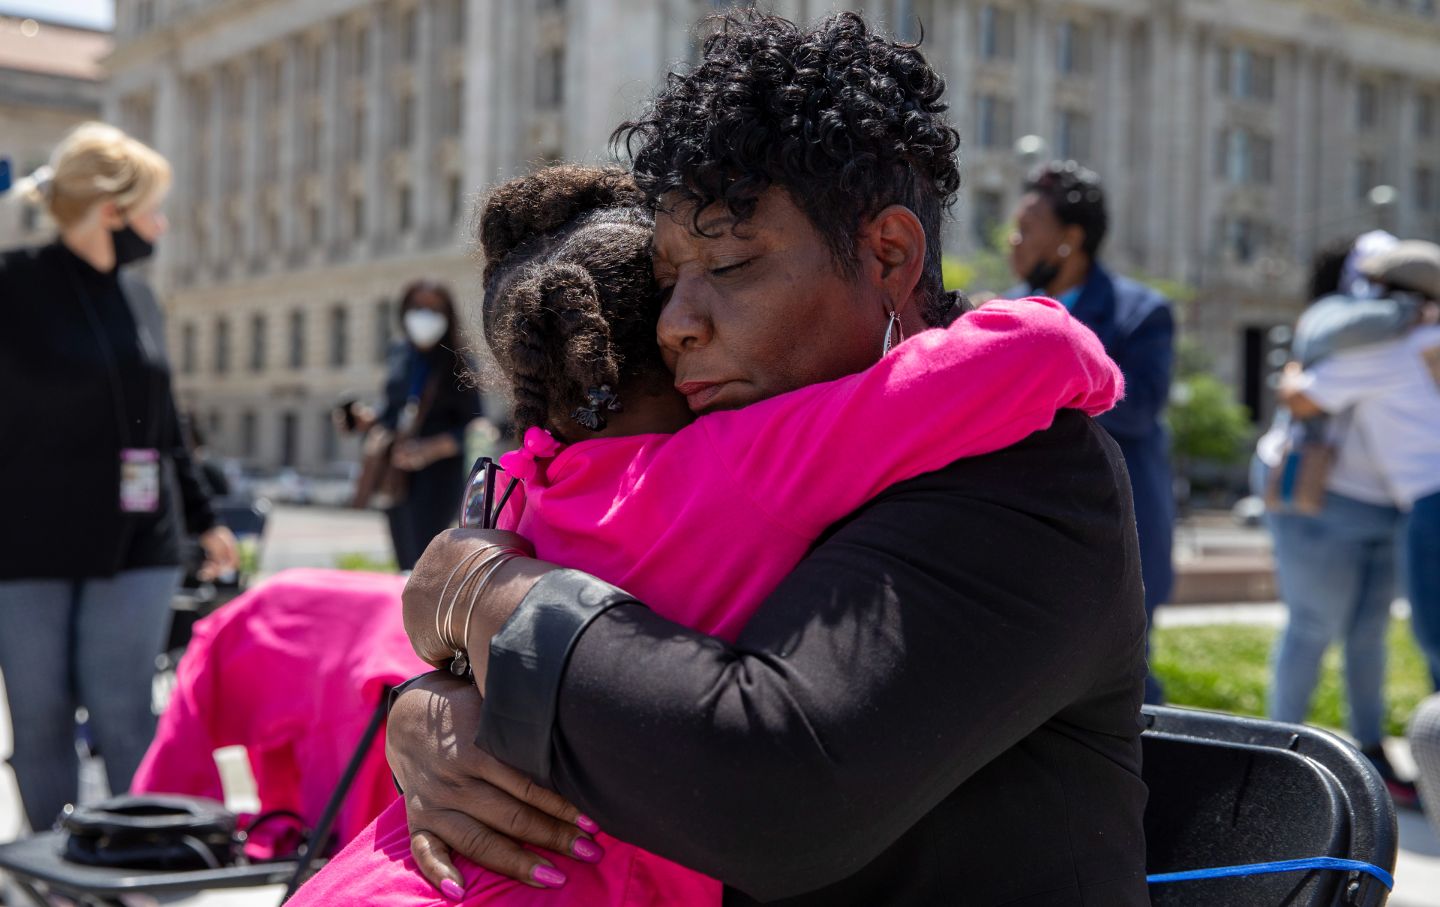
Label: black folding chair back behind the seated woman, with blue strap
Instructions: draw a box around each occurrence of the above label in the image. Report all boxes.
[1142,707,1398,907]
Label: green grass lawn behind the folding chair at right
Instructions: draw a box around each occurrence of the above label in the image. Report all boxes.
[1151,621,1430,737]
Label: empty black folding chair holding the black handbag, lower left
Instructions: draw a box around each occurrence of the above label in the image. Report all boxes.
[0,690,390,907]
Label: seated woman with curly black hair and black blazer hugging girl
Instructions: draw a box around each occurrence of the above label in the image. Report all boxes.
[387,13,1149,907]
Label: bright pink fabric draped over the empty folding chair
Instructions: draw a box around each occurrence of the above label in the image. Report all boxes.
[132,570,429,857]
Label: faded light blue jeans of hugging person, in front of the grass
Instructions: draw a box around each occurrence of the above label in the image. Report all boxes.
[1266,494,1401,746]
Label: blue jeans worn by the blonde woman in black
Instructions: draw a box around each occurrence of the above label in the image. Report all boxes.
[0,567,180,831]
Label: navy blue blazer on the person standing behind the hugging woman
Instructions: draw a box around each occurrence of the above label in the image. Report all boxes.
[1012,265,1175,612]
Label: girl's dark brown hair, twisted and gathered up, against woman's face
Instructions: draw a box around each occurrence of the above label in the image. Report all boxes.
[478,166,670,441]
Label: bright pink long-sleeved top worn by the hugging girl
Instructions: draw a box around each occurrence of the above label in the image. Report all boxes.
[289,298,1123,907]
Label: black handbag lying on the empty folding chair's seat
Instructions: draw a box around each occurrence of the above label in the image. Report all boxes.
[59,793,239,870]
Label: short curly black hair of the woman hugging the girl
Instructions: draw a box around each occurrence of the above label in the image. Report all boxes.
[612,10,960,324]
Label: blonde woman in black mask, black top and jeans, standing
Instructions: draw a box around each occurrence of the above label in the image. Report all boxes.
[0,122,236,829]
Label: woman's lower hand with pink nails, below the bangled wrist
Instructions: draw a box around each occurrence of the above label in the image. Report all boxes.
[386,671,603,900]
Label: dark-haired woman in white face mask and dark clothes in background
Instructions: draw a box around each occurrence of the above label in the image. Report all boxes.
[344,281,481,570]
